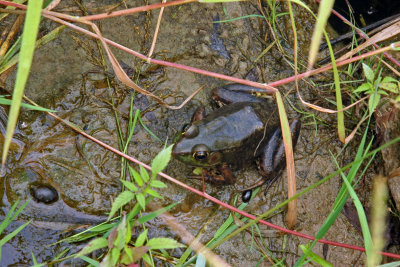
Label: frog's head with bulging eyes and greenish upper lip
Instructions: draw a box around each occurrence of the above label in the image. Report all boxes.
[172,124,222,167]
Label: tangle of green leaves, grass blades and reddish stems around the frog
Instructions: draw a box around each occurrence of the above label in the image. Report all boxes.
[0,0,400,266]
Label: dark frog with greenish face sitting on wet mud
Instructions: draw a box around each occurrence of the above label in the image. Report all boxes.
[172,84,301,198]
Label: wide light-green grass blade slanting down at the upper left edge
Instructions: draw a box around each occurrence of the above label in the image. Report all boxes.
[2,0,43,165]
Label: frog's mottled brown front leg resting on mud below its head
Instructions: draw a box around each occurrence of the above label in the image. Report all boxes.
[189,164,236,185]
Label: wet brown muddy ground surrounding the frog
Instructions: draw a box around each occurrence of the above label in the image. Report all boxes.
[1,1,372,266]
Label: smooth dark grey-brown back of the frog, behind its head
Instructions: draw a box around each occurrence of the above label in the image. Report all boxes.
[198,102,277,167]
